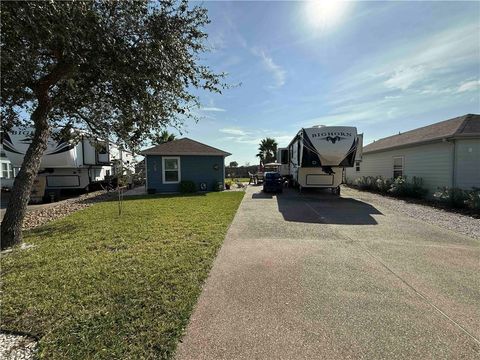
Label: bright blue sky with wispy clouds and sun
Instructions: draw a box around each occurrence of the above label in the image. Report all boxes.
[174,1,480,165]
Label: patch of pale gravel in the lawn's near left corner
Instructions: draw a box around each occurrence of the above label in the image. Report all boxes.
[0,333,37,360]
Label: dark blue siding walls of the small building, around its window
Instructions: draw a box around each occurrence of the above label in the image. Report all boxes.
[146,155,225,193]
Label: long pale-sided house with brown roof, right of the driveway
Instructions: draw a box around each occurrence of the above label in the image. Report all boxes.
[346,114,480,194]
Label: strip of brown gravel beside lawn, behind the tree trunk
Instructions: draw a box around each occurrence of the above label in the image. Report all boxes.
[23,191,116,230]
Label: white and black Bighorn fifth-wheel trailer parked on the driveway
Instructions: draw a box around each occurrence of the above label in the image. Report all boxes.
[288,126,363,194]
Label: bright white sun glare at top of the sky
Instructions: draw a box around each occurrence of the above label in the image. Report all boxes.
[305,0,348,29]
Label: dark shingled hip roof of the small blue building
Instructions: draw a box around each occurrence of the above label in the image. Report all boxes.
[140,138,232,156]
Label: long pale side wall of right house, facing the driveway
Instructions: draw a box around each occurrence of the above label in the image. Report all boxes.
[346,142,454,196]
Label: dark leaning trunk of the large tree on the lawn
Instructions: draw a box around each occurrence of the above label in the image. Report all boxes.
[1,102,51,250]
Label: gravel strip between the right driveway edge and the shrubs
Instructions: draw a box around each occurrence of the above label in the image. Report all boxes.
[342,187,480,239]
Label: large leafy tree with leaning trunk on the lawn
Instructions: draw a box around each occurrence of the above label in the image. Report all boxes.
[1,0,224,248]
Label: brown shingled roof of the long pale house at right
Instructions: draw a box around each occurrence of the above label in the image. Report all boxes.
[363,114,480,153]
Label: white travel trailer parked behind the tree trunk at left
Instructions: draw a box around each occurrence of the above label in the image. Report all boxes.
[2,128,135,197]
